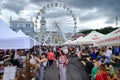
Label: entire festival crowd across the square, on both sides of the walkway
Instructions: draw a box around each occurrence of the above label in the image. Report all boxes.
[0,45,120,80]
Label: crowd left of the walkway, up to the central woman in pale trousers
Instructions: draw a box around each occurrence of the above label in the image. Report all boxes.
[0,46,68,80]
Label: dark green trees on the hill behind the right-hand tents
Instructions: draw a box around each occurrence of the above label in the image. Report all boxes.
[79,26,118,34]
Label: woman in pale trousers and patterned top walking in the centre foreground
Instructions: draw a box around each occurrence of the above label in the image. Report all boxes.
[56,50,68,80]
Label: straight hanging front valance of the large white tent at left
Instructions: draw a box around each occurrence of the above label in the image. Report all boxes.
[0,37,33,49]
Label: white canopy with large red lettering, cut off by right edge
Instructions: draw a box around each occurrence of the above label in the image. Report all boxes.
[95,28,120,46]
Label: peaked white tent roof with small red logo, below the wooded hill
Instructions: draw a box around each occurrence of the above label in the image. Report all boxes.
[79,31,105,44]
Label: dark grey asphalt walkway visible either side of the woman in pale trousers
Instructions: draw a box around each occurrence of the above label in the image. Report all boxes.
[45,57,89,80]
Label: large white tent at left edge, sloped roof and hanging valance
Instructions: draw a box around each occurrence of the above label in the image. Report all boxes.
[0,19,33,49]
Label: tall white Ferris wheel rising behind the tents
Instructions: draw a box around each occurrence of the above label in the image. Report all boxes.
[35,2,77,41]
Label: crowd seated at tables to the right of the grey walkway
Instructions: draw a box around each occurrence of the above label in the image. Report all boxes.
[78,46,120,80]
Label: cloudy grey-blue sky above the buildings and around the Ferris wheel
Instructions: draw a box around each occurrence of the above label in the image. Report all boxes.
[0,0,120,30]
